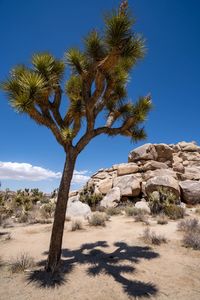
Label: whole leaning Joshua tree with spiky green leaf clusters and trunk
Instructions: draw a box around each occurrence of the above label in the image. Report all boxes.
[2,1,151,272]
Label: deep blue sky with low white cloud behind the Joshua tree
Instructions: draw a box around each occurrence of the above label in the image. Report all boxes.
[0,0,200,192]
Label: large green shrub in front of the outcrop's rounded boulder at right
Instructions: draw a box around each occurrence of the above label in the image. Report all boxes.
[148,187,179,215]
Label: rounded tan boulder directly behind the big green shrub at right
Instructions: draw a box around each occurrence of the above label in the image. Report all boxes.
[145,175,180,199]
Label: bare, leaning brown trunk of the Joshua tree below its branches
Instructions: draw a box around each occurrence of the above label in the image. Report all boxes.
[46,151,76,273]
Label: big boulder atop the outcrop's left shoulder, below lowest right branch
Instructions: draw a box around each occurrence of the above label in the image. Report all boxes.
[128,144,157,162]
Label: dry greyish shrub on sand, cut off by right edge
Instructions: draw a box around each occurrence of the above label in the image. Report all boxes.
[178,218,200,250]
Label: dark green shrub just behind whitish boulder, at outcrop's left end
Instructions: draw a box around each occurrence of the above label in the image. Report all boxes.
[80,184,103,210]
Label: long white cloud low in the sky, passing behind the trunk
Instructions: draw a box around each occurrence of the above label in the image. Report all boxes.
[0,162,90,185]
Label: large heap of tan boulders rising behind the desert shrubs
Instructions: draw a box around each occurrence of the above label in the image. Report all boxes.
[79,142,200,207]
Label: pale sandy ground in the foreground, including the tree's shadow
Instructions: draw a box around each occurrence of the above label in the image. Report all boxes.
[0,212,200,300]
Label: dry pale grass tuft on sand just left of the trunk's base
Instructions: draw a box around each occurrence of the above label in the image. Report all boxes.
[10,253,34,273]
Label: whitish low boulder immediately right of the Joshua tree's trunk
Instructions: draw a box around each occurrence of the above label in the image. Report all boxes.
[66,195,91,218]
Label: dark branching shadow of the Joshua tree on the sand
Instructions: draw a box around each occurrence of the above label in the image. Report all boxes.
[26,241,159,297]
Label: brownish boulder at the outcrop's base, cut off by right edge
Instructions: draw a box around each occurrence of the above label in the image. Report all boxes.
[179,180,200,204]
